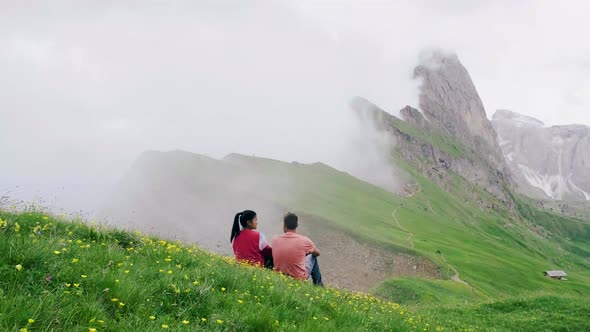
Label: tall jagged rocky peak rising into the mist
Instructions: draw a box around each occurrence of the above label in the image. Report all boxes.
[352,54,513,205]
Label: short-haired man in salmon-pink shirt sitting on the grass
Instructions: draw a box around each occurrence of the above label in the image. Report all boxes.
[271,213,323,286]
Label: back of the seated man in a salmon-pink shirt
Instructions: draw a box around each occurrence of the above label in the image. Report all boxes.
[271,232,317,280]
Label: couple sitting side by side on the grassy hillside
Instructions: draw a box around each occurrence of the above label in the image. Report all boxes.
[230,210,323,286]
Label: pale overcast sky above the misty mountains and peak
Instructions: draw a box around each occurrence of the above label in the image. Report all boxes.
[0,0,590,207]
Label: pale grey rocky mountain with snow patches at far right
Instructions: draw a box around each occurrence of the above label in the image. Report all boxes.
[492,110,590,200]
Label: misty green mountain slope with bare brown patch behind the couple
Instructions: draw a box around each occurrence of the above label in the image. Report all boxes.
[105,148,590,302]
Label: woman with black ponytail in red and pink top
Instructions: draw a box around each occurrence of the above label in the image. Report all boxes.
[230,210,272,268]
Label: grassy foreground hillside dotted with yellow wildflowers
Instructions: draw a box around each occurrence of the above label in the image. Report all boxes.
[0,212,434,331]
